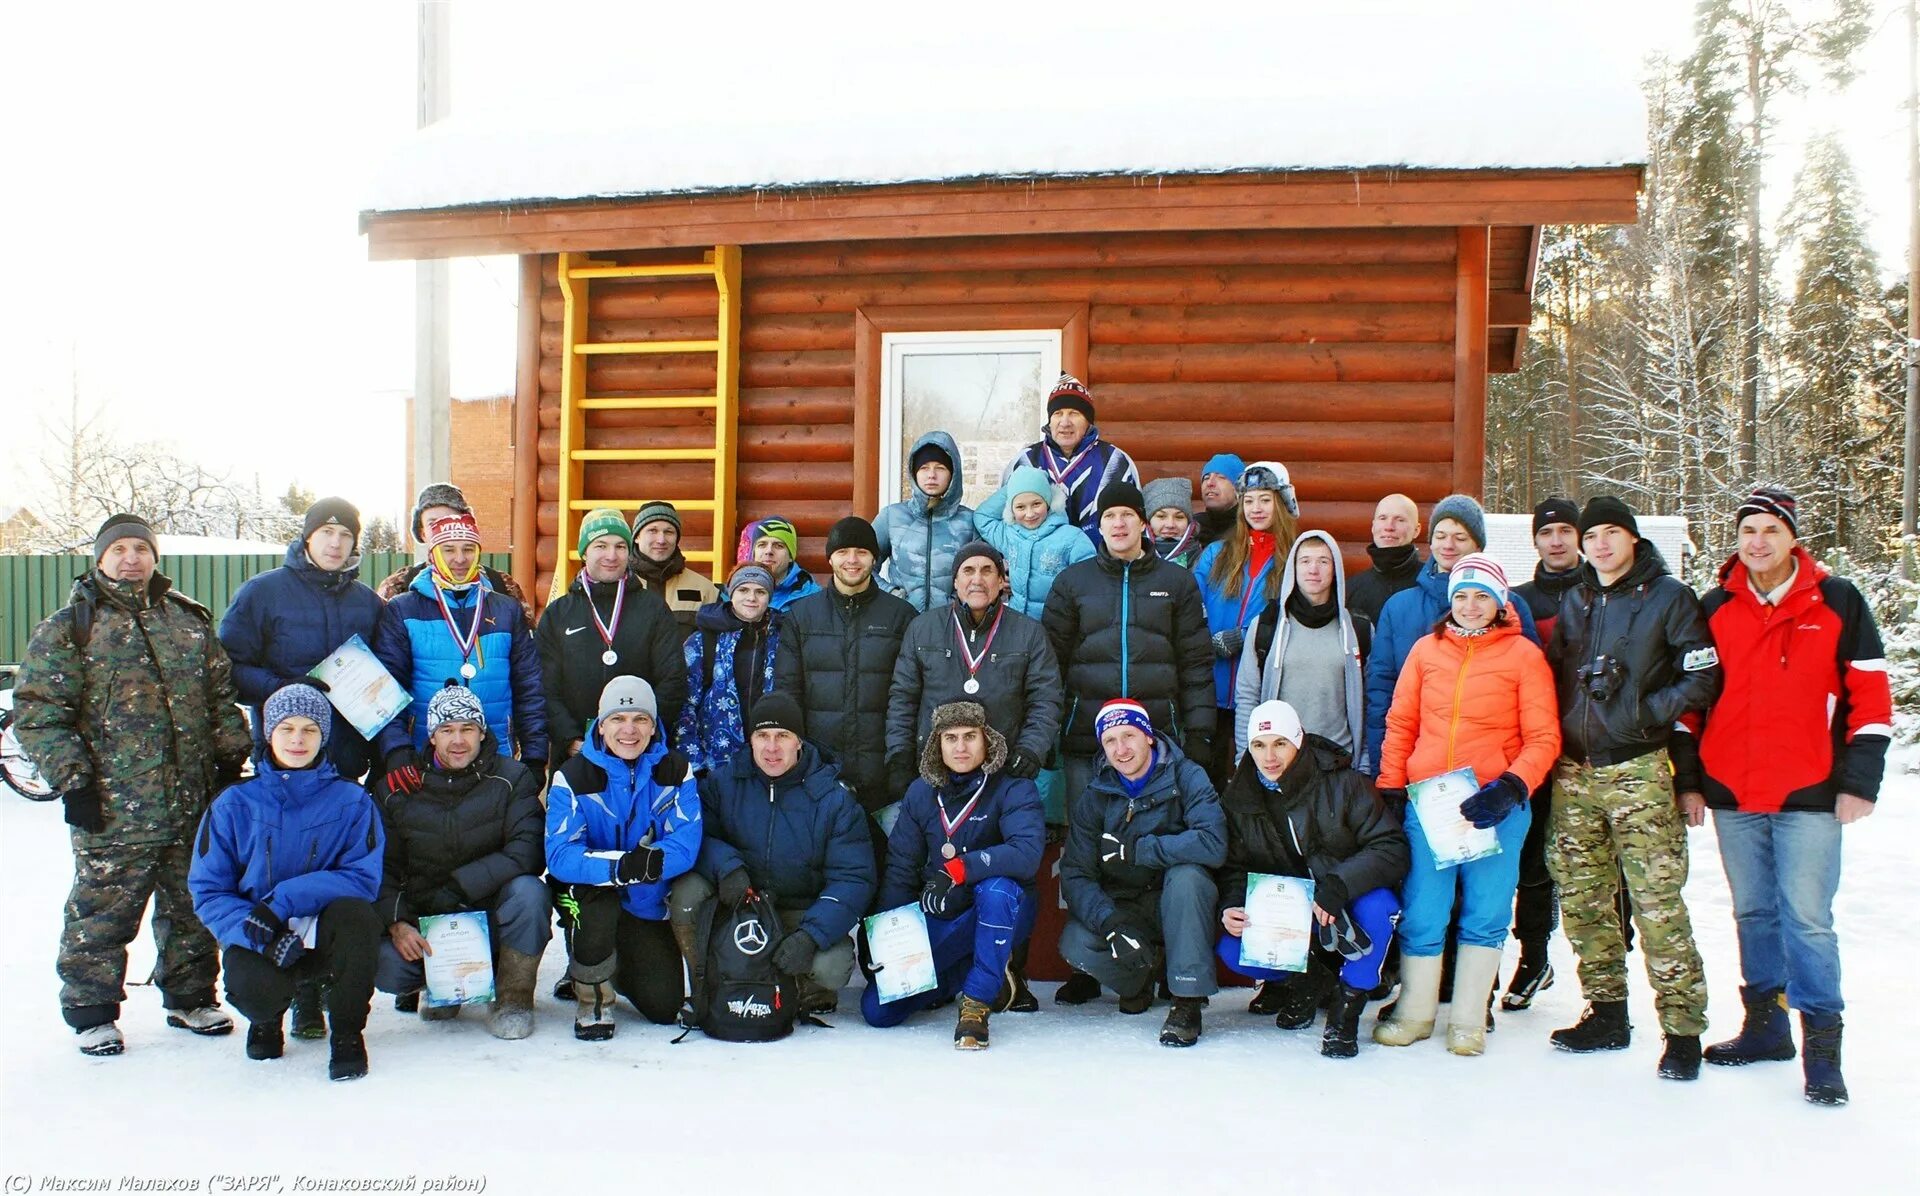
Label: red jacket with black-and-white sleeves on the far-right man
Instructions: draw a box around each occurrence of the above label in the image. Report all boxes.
[1676,545,1893,814]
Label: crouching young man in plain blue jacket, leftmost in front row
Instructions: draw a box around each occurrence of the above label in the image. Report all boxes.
[186,685,384,1079]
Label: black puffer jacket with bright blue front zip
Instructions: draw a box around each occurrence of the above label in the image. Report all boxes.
[1041,545,1217,756]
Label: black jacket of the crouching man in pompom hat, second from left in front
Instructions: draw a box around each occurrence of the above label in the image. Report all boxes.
[372,731,547,925]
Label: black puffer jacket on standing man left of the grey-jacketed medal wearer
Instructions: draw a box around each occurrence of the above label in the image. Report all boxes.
[774,584,914,810]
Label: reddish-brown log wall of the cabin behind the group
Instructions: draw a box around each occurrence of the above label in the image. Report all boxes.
[536,228,1484,593]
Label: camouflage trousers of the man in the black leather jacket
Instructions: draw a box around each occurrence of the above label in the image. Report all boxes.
[1548,751,1707,1035]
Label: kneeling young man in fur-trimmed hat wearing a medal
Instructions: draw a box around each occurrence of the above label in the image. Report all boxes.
[860,703,1046,1050]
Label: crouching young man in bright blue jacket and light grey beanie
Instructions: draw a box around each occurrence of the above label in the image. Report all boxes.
[547,678,701,1042]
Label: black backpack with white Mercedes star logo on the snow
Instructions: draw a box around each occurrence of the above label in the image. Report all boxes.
[674,891,801,1042]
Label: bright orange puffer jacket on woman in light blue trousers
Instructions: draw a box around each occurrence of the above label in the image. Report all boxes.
[1379,618,1559,793]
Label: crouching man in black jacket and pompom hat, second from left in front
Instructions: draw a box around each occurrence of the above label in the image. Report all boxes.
[372,683,553,1039]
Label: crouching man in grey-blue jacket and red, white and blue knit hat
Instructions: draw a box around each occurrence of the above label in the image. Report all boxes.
[1060,697,1227,1046]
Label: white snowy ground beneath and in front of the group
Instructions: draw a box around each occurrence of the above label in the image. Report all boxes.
[0,760,1920,1192]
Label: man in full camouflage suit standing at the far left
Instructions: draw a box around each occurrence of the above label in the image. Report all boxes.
[13,514,252,1054]
